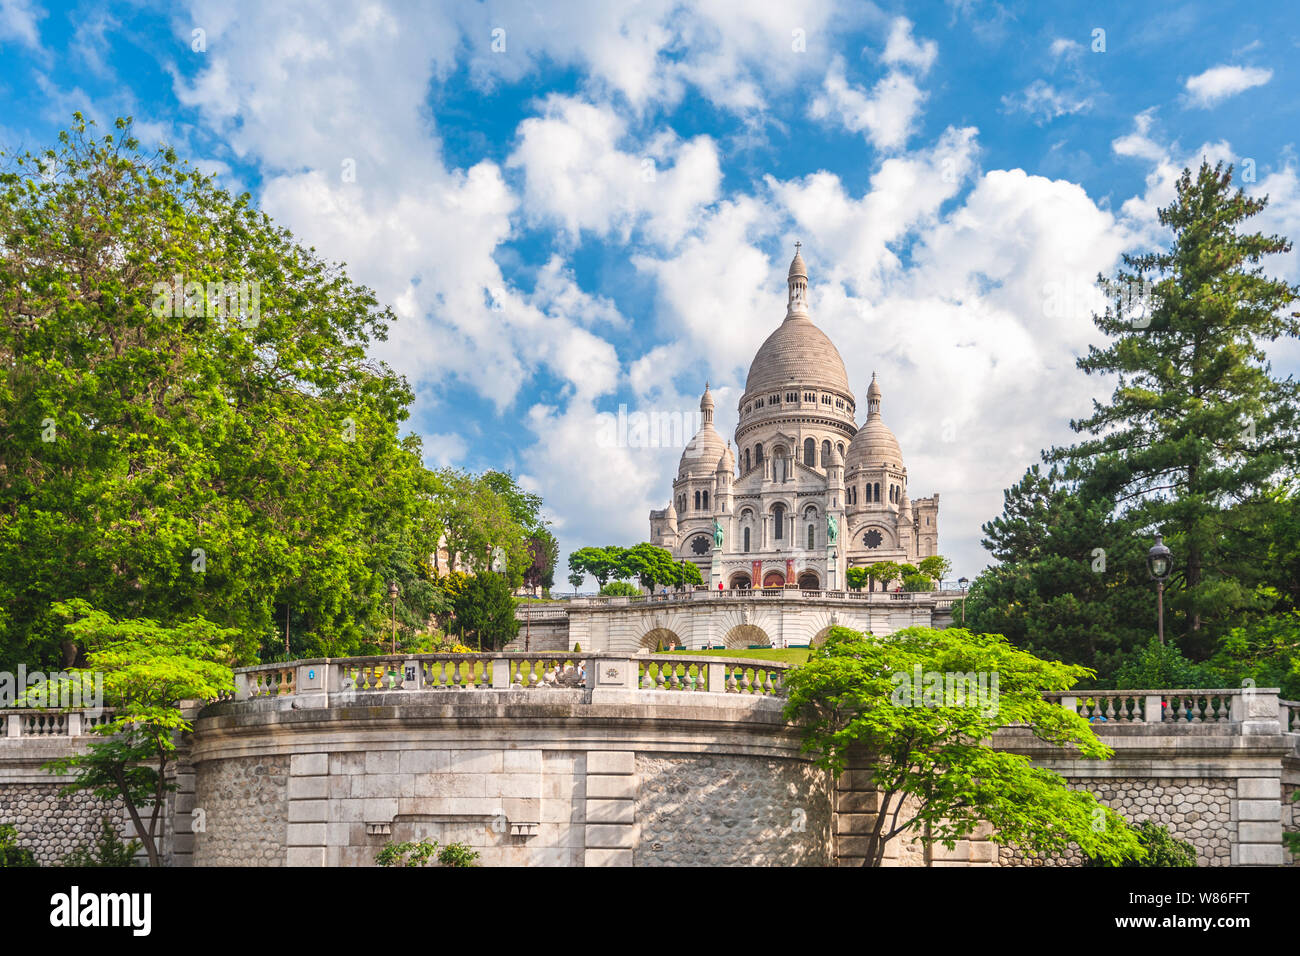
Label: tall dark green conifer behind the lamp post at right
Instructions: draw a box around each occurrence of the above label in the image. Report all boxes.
[1048,163,1300,658]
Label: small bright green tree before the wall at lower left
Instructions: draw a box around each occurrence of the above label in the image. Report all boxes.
[46,600,239,866]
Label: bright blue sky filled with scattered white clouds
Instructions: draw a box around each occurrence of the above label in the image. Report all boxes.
[0,0,1300,576]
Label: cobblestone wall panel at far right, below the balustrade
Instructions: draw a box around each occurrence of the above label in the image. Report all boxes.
[997,777,1236,866]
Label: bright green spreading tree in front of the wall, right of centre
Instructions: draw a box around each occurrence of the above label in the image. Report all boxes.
[785,627,1141,866]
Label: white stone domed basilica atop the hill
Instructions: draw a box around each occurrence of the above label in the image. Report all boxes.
[650,251,939,591]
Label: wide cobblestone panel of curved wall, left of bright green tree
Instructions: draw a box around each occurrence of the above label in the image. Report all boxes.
[634,753,831,866]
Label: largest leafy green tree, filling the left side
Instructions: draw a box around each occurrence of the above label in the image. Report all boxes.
[0,114,452,665]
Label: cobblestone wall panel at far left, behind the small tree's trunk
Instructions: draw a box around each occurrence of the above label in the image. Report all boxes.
[0,782,125,866]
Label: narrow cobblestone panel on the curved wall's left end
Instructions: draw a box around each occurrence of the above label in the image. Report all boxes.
[194,757,289,866]
